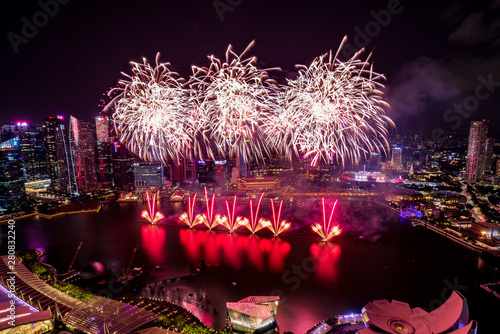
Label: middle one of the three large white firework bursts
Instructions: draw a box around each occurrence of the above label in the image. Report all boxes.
[190,42,276,162]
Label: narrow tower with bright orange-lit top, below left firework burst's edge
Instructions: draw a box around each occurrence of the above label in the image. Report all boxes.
[95,116,113,188]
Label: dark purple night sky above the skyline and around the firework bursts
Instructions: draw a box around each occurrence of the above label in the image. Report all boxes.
[0,0,500,134]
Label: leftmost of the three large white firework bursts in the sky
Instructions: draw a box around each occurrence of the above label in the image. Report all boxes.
[105,53,195,162]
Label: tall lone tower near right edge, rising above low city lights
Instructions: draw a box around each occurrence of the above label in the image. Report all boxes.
[466,120,488,183]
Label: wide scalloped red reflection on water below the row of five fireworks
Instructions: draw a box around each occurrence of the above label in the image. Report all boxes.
[179,229,290,272]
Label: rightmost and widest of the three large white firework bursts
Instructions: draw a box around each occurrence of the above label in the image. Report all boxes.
[265,38,394,165]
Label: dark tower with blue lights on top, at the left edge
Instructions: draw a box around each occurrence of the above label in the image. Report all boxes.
[0,137,26,212]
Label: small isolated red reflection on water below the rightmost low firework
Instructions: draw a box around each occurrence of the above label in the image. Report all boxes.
[310,243,340,282]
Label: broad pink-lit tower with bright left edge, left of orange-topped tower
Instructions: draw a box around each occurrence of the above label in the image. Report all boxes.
[69,116,97,193]
